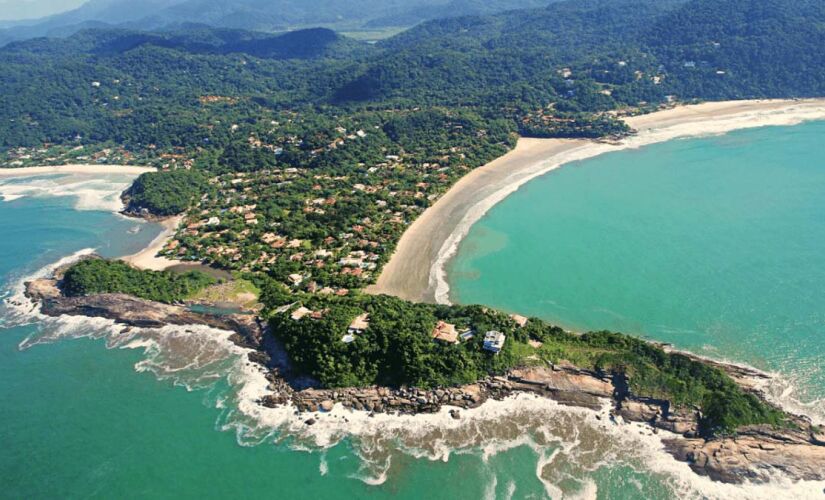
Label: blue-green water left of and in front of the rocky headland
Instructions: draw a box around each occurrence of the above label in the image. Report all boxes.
[0,179,674,499]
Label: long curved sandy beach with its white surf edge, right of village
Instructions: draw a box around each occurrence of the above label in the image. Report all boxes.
[367,99,825,303]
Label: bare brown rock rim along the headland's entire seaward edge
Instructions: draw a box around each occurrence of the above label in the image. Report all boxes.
[26,271,825,483]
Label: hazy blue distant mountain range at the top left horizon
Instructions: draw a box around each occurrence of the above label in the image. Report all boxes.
[0,0,554,45]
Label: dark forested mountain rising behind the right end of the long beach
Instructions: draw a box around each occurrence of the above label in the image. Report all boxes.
[336,0,825,107]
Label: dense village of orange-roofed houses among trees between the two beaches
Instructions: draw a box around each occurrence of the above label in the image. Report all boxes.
[166,151,454,293]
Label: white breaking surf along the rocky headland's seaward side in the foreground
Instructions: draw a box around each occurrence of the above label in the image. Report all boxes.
[0,256,825,499]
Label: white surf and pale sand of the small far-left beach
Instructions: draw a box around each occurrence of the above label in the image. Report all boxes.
[0,174,134,212]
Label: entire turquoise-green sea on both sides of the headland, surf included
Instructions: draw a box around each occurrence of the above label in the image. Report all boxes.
[0,124,825,499]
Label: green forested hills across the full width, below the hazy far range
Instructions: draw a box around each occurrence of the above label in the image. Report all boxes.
[0,0,825,147]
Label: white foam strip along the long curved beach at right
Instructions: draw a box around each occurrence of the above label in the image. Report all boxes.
[429,105,825,304]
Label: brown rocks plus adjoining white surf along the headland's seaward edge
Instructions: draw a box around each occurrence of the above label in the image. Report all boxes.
[17,251,825,490]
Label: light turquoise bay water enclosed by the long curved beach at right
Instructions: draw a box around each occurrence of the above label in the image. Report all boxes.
[448,122,825,415]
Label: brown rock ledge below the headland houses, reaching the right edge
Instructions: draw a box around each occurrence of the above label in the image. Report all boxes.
[261,366,825,483]
